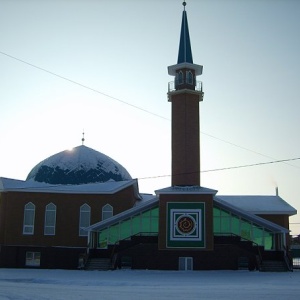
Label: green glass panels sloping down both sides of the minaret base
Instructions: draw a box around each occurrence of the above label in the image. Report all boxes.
[97,206,275,250]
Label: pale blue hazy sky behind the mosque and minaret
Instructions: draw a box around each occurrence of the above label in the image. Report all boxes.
[0,0,300,234]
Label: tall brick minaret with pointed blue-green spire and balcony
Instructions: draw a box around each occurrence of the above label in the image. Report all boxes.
[168,2,203,186]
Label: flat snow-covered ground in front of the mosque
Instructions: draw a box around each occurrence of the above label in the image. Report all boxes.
[0,269,300,300]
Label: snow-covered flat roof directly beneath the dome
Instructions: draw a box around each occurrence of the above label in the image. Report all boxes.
[0,177,140,198]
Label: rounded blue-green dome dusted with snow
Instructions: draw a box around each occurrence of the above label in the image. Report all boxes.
[26,145,132,184]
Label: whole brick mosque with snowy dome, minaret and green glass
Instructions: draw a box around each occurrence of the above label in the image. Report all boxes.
[0,2,297,271]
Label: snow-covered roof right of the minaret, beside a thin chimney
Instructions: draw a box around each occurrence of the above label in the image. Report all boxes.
[218,195,297,216]
